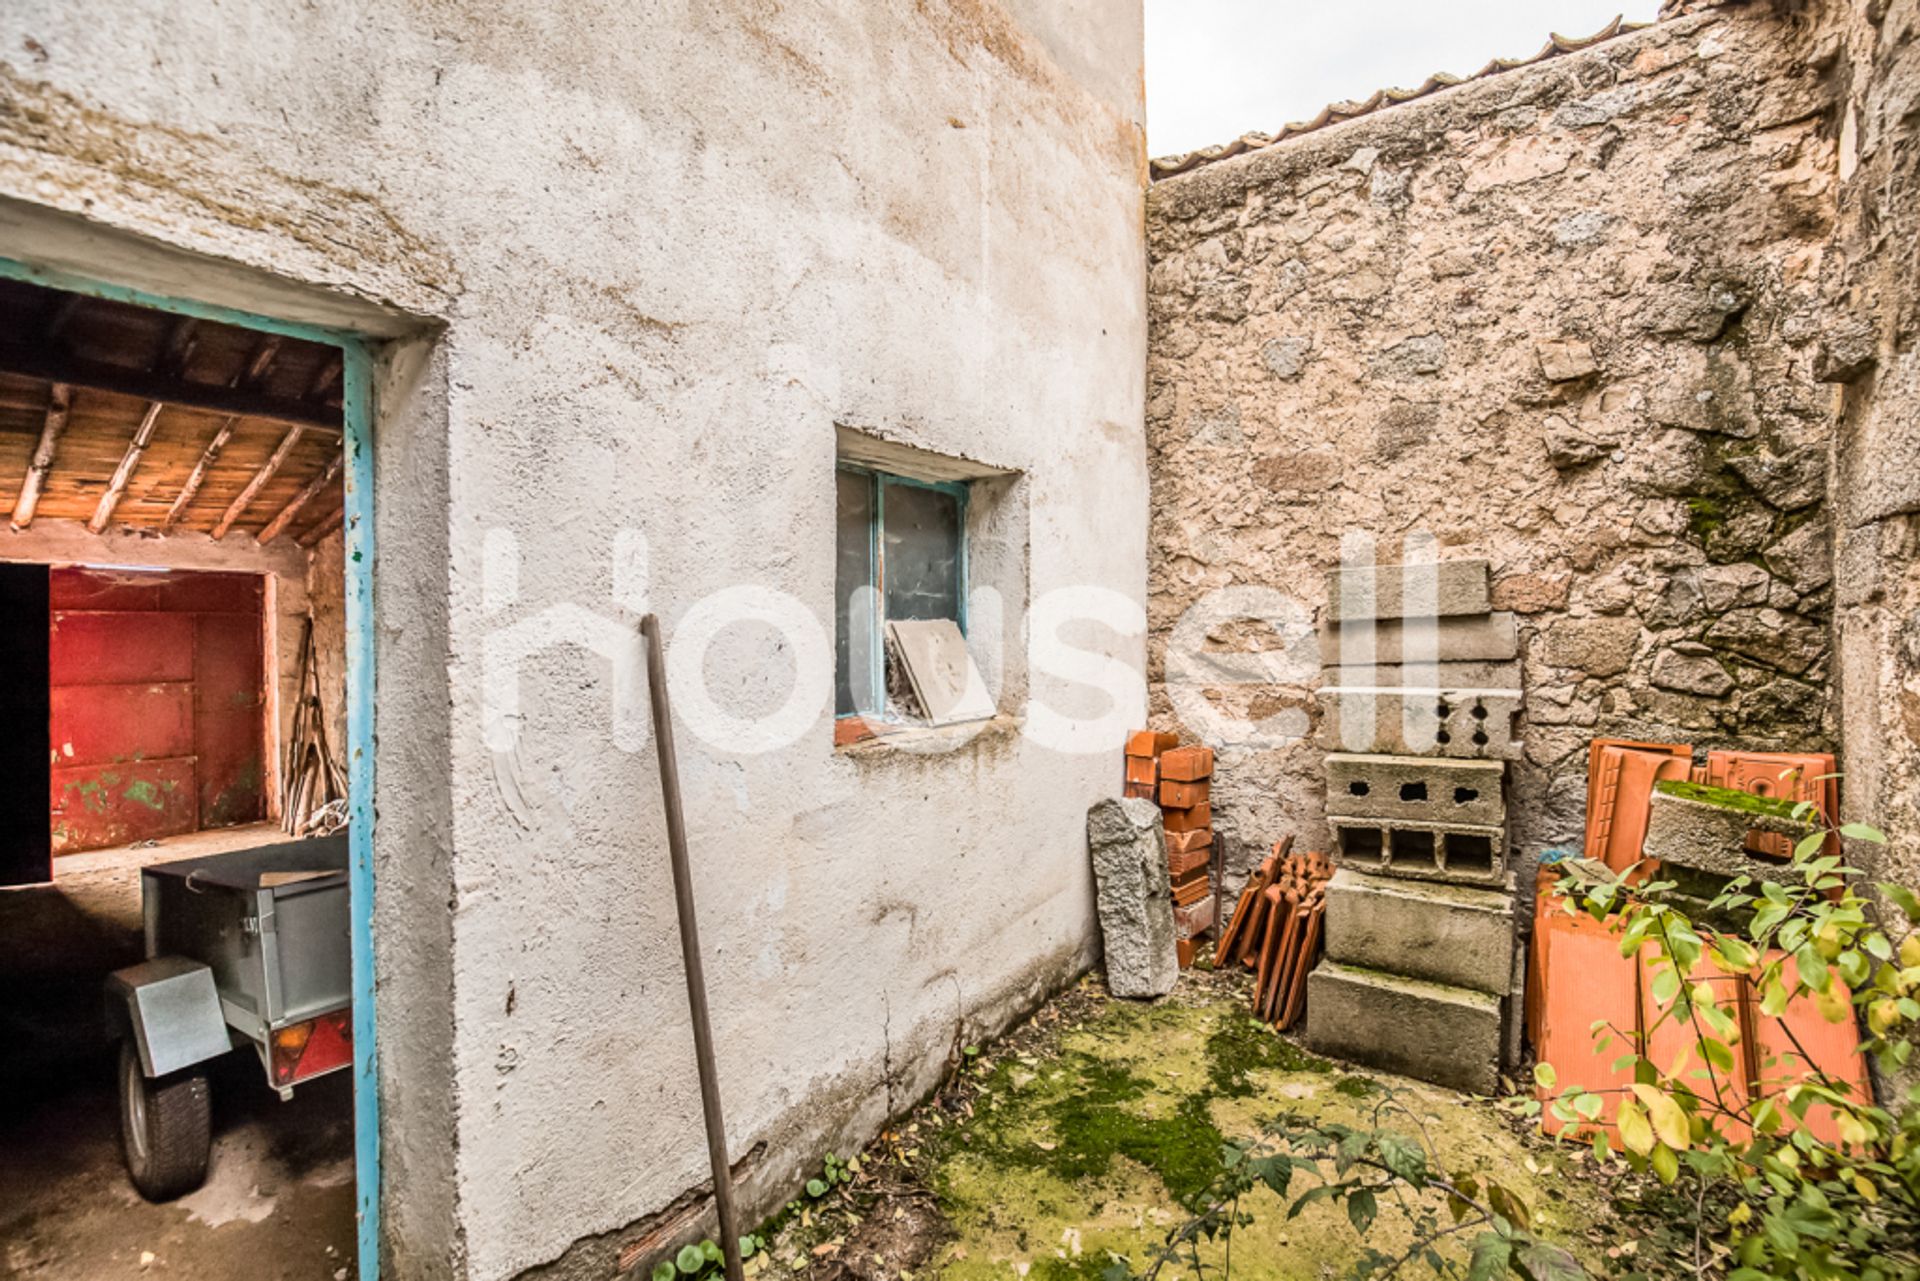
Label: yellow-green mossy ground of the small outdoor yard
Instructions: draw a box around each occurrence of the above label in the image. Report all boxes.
[748,974,1666,1281]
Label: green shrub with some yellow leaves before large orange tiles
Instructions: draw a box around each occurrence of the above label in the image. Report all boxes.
[1536,803,1920,1281]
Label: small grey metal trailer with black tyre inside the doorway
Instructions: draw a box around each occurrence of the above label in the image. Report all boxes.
[108,832,353,1200]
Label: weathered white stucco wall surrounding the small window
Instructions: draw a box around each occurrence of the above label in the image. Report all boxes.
[0,0,1146,1281]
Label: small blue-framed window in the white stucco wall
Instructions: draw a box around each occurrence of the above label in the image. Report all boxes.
[833,463,968,720]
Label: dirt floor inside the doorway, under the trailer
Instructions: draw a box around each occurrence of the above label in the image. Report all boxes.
[0,826,353,1281]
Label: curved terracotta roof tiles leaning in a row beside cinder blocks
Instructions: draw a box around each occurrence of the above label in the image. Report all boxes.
[1213,837,1332,1031]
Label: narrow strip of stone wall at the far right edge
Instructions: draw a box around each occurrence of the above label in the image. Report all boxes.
[1816,0,1920,902]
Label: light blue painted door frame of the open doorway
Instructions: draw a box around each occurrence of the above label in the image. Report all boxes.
[0,257,380,1281]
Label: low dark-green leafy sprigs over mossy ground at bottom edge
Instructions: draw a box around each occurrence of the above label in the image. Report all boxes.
[1102,1089,1586,1281]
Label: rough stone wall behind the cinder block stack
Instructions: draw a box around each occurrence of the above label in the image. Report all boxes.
[1148,4,1837,871]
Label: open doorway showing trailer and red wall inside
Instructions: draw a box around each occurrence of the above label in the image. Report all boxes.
[0,278,359,1281]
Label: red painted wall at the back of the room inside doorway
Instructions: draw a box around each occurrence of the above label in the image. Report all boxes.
[48,568,267,855]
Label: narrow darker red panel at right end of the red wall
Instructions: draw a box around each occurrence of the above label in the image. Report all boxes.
[194,611,267,828]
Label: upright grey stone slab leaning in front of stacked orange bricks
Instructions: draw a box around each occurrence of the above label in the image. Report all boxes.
[1087,797,1181,997]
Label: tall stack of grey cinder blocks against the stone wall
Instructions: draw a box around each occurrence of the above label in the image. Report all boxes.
[1308,561,1523,1093]
